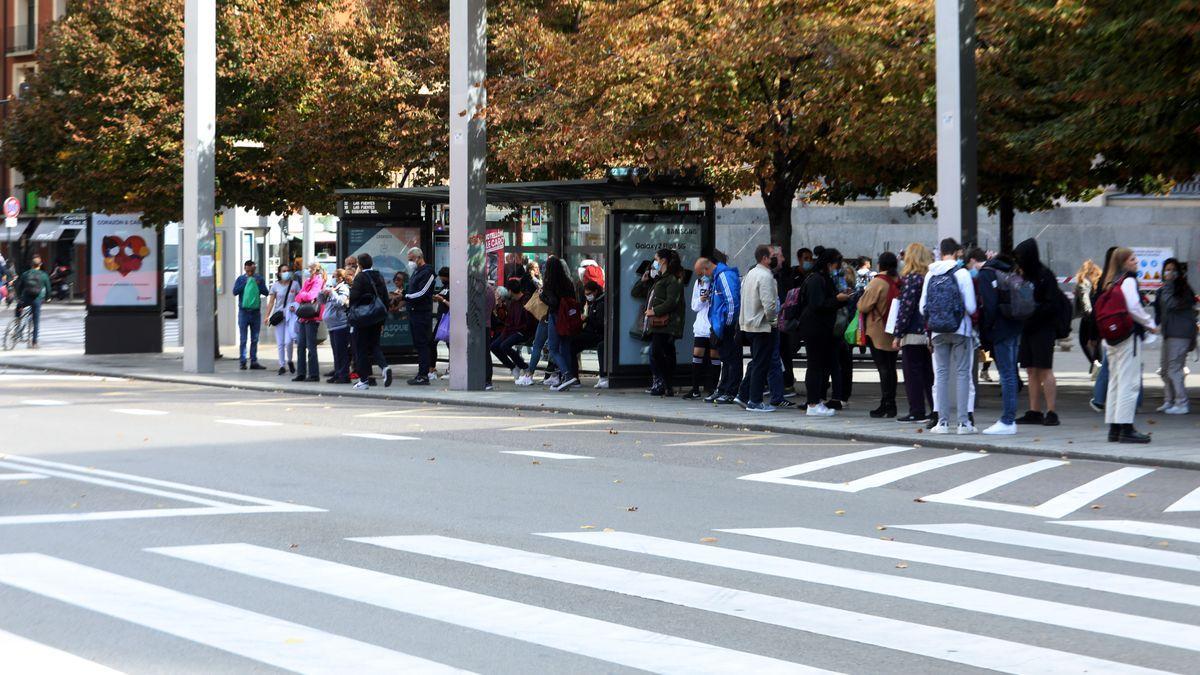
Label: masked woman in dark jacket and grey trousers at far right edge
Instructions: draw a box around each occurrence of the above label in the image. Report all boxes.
[1154,258,1196,414]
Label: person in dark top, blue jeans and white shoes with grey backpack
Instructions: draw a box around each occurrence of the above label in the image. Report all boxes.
[977,256,1025,436]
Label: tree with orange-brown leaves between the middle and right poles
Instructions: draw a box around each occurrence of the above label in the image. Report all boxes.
[488,0,934,245]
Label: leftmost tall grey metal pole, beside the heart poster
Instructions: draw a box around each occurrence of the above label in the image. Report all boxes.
[179,0,217,372]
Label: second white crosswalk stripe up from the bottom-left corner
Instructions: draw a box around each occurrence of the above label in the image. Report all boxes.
[0,554,455,674]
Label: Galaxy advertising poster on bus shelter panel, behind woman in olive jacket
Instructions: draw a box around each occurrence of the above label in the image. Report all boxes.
[617,220,702,365]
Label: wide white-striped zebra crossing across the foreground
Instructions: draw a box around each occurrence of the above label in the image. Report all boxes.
[0,520,1200,674]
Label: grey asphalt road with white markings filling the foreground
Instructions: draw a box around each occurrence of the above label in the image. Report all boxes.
[0,371,1200,673]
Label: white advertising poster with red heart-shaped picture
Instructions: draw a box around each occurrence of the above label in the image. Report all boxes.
[88,214,158,307]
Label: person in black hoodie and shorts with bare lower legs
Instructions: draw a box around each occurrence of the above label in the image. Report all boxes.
[1013,239,1062,426]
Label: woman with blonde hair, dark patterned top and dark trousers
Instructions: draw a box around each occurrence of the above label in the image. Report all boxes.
[892,243,937,423]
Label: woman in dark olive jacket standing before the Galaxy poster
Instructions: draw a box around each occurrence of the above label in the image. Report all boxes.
[631,249,684,396]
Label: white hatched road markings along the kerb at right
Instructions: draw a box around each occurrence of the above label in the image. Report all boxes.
[738,446,1200,519]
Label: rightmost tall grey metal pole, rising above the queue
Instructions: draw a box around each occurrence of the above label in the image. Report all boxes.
[936,0,979,243]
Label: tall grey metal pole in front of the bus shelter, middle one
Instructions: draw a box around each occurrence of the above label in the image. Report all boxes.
[448,0,490,392]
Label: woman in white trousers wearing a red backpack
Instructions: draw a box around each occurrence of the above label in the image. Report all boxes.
[1097,247,1158,443]
